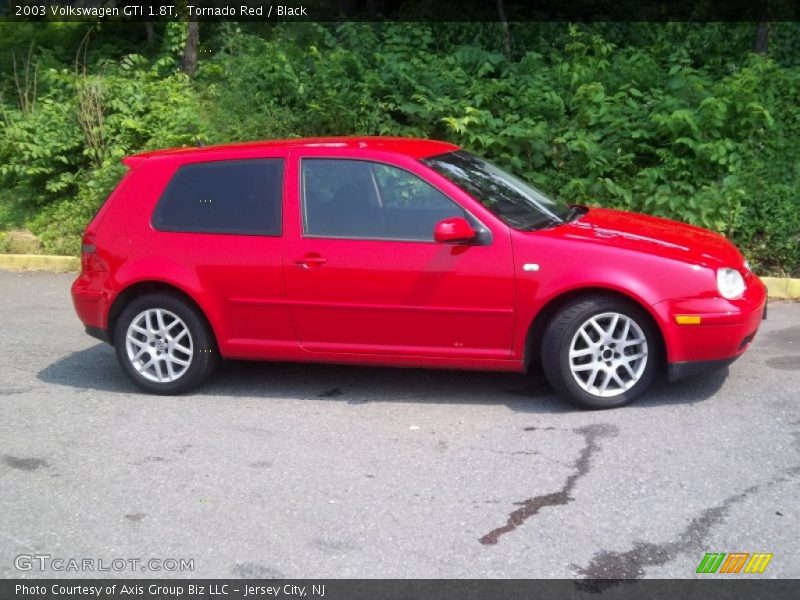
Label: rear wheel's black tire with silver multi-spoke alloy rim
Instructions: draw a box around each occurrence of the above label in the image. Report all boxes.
[114,292,219,395]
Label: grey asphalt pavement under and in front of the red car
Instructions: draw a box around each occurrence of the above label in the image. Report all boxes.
[0,272,800,578]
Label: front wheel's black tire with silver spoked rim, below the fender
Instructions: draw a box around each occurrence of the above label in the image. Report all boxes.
[541,294,661,409]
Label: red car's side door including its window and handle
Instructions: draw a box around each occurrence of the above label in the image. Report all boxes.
[283,156,514,359]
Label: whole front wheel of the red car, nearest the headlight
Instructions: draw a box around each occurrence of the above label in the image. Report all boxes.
[541,295,661,409]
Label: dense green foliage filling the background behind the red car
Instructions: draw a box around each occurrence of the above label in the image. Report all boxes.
[0,21,800,274]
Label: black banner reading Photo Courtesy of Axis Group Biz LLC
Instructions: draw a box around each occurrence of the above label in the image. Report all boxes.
[0,576,800,600]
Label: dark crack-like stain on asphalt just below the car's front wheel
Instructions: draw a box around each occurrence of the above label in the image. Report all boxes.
[479,424,618,546]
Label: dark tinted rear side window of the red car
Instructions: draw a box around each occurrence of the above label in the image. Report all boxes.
[153,158,283,236]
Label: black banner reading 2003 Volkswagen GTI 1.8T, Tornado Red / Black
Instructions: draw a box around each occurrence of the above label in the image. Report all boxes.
[0,0,800,22]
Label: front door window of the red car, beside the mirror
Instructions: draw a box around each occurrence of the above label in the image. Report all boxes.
[302,158,465,241]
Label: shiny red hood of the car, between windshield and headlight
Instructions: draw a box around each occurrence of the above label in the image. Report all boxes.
[552,208,744,268]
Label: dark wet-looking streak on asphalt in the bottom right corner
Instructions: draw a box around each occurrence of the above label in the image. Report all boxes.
[572,467,800,592]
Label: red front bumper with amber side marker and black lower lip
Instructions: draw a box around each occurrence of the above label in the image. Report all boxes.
[653,275,767,370]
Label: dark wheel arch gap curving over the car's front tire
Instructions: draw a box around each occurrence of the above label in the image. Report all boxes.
[524,286,667,371]
